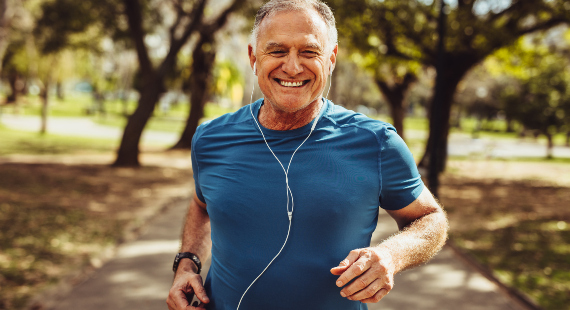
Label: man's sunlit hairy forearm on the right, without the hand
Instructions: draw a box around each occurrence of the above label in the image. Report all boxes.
[376,208,448,273]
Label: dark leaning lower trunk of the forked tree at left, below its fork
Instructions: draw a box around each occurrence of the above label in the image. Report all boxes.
[113,72,164,167]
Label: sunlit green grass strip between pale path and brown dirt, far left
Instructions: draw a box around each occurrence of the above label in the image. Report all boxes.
[0,124,119,155]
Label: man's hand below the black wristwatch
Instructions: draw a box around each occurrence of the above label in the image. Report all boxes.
[166,264,210,310]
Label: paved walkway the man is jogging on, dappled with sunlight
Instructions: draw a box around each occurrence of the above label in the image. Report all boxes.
[46,202,524,310]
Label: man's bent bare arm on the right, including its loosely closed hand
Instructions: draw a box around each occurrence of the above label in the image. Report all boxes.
[331,188,447,303]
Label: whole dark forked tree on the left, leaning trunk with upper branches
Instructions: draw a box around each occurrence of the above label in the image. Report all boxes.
[33,0,244,166]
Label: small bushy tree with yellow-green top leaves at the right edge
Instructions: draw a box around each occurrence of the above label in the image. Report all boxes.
[486,35,570,158]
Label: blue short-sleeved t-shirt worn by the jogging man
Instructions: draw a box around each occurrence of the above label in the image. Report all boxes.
[192,99,423,310]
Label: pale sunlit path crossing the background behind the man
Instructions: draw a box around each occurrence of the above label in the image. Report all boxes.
[0,113,570,158]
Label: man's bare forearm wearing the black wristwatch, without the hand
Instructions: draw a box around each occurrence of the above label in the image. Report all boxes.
[179,196,212,272]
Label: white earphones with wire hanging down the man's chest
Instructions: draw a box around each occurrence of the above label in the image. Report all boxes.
[236,62,333,310]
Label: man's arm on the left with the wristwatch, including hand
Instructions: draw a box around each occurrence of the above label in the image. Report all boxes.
[166,194,212,310]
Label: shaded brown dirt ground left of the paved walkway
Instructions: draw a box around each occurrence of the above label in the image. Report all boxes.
[0,156,192,309]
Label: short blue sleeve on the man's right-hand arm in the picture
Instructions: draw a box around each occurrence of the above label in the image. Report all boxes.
[379,127,424,210]
